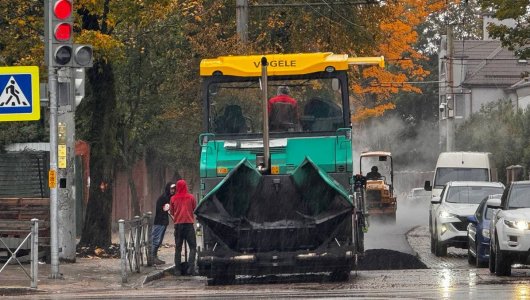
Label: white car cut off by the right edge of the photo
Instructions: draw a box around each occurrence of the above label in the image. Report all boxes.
[489,181,530,276]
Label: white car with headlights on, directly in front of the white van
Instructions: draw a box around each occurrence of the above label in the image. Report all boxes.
[429,181,504,256]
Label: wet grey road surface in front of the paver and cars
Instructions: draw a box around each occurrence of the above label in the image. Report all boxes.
[5,198,530,299]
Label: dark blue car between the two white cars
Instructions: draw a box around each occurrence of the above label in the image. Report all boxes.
[467,194,502,268]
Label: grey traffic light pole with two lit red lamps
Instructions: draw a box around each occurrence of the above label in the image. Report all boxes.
[44,0,93,272]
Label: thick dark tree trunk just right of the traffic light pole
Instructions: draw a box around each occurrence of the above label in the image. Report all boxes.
[80,61,116,247]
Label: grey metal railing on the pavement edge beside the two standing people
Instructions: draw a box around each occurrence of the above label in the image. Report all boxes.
[118,212,153,283]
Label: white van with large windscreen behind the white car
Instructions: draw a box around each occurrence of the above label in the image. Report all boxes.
[425,152,497,197]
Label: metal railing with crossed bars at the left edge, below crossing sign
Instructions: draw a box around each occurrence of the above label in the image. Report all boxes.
[0,219,39,289]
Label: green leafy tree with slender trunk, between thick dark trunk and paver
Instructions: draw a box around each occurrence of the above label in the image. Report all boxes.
[111,7,201,214]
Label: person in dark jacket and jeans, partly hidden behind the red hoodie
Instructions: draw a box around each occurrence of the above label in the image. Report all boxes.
[151,182,175,265]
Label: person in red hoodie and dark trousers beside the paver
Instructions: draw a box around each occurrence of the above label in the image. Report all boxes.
[170,179,197,275]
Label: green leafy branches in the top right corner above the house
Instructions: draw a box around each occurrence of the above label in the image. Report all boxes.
[479,0,530,59]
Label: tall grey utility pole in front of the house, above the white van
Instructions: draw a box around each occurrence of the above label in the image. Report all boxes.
[445,24,455,152]
